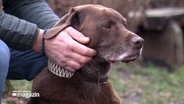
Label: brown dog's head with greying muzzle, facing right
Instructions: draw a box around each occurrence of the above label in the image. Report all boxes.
[48,5,144,78]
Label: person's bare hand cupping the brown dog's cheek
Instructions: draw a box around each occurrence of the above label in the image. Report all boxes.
[45,27,96,71]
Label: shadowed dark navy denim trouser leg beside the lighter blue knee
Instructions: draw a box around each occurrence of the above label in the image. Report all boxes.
[7,49,47,80]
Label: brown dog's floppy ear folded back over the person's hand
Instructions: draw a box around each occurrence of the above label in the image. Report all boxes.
[44,8,80,39]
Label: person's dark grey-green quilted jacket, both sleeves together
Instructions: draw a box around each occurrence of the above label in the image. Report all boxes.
[0,0,59,50]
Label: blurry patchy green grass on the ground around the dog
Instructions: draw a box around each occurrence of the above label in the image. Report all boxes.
[3,63,184,104]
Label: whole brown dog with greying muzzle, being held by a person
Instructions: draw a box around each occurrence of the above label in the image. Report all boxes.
[28,5,144,104]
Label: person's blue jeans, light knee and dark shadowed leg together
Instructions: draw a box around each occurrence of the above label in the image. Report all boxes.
[0,40,47,100]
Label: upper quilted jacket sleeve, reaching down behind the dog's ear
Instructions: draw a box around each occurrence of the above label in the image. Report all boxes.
[4,0,59,29]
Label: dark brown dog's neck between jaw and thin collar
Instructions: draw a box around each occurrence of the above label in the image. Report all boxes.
[76,56,111,84]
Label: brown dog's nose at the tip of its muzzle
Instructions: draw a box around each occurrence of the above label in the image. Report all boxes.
[132,36,144,49]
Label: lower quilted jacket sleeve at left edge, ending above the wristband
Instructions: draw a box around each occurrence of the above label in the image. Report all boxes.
[0,12,39,50]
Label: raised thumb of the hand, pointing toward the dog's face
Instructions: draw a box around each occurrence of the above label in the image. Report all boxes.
[65,27,90,44]
